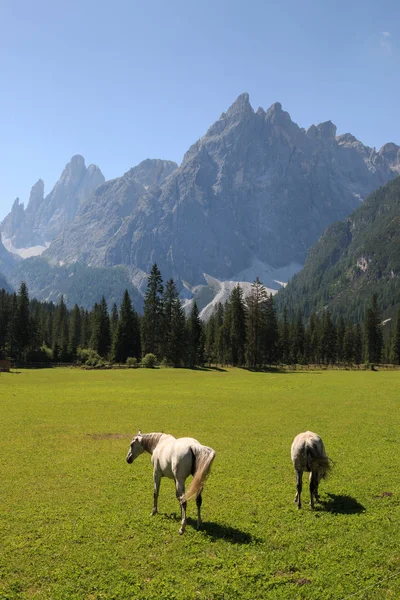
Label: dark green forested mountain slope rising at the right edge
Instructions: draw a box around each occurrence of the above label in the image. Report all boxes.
[276,177,400,320]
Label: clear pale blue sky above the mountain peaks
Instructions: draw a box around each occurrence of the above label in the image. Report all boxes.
[0,0,400,220]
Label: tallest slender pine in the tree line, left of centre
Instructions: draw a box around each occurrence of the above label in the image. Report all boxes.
[142,264,164,357]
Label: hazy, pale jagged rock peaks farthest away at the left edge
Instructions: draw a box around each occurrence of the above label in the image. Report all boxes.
[0,155,104,258]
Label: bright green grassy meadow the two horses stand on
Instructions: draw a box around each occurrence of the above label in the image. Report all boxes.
[0,369,400,600]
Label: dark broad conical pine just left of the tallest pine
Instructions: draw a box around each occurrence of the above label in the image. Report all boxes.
[111,290,141,363]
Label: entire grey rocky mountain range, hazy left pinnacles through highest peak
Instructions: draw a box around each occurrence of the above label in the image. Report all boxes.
[0,94,400,310]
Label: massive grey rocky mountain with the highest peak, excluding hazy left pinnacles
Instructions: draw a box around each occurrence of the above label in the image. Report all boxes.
[44,94,400,288]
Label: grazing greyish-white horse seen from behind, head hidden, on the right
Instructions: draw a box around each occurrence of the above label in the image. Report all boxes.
[291,431,331,508]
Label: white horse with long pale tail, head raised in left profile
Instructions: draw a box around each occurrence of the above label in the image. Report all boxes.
[126,431,215,534]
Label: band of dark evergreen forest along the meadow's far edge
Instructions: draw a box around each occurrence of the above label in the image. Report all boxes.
[0,264,400,369]
